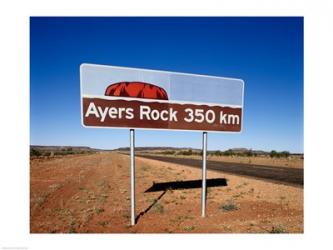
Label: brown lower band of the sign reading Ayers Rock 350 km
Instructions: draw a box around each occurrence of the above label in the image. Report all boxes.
[83,98,242,132]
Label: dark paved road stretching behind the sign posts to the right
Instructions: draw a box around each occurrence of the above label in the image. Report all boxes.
[138,155,303,186]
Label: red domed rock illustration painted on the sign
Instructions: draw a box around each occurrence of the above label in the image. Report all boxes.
[105,82,169,100]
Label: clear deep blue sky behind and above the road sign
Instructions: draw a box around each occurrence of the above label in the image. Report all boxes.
[30,17,303,152]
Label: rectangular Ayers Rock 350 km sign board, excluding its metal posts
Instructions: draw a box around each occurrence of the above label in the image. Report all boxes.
[80,64,244,132]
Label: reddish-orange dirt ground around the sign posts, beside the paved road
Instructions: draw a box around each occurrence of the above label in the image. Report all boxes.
[30,152,303,233]
